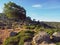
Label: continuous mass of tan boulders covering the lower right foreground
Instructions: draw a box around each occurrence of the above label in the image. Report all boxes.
[24,31,60,45]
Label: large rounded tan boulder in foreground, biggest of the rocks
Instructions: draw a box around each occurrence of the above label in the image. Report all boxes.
[33,31,50,45]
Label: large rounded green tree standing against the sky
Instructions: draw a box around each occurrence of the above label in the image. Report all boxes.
[3,2,26,19]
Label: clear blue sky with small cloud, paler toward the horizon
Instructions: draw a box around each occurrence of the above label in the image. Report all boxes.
[0,0,60,22]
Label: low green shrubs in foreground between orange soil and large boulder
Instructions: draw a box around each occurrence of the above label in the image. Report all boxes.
[3,31,34,45]
